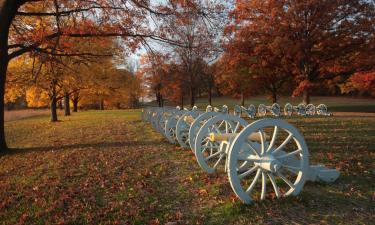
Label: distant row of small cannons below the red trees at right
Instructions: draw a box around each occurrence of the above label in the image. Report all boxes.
[235,103,332,118]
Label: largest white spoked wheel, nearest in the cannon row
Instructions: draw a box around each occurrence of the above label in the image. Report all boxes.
[228,119,309,204]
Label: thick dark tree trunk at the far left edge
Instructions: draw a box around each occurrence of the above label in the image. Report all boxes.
[0,0,24,152]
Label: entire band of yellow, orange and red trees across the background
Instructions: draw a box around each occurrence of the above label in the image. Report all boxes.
[5,0,375,118]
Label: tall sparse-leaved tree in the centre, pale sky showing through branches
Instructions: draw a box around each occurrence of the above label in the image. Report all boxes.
[156,0,224,107]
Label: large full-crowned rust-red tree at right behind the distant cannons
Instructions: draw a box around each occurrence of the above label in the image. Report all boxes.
[229,0,375,103]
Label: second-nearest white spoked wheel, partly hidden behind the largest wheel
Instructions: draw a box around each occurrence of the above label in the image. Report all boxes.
[194,114,248,174]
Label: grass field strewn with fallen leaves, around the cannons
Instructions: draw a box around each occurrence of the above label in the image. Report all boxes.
[0,110,375,225]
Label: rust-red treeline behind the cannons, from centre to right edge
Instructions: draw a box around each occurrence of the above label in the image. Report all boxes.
[140,0,375,106]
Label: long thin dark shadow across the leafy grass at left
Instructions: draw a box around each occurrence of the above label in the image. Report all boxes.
[0,141,164,156]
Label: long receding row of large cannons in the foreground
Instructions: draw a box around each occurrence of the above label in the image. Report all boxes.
[142,107,339,204]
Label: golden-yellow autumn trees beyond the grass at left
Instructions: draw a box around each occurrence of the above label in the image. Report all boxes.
[5,39,142,121]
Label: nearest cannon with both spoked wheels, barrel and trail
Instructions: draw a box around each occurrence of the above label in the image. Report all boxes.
[195,115,339,203]
